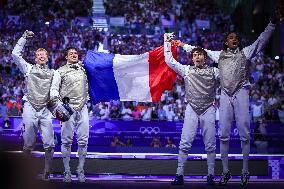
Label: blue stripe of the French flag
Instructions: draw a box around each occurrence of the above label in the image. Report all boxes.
[84,51,120,103]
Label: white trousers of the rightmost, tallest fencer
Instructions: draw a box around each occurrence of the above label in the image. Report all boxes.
[220,88,250,173]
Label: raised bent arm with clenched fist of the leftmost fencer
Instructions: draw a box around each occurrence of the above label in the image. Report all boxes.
[12,30,34,74]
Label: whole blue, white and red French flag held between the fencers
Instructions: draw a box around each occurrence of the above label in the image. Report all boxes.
[83,44,177,103]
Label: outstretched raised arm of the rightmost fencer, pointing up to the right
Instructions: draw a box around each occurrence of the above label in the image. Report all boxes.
[243,22,275,59]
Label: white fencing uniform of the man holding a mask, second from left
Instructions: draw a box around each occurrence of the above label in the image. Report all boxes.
[51,63,89,172]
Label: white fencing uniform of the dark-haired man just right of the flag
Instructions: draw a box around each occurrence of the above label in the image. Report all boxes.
[164,42,219,175]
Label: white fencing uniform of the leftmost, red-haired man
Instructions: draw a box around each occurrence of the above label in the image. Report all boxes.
[12,37,54,172]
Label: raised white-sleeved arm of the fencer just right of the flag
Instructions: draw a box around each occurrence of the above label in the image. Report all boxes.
[164,33,186,77]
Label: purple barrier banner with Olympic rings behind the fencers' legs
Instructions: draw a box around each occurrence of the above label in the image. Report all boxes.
[0,118,284,153]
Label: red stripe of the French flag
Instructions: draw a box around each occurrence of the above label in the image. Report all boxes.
[149,45,177,102]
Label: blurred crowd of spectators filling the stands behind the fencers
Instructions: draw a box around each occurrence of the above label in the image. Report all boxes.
[0,0,284,125]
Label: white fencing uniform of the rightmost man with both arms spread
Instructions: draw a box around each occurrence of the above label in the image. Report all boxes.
[184,23,275,173]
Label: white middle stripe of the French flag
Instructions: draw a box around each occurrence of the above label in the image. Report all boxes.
[113,53,152,102]
